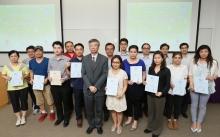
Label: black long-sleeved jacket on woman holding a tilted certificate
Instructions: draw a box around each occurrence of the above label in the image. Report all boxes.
[148,67,171,97]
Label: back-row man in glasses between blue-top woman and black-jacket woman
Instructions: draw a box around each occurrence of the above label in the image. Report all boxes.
[141,43,153,116]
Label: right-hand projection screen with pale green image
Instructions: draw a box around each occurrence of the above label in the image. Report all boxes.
[120,0,199,51]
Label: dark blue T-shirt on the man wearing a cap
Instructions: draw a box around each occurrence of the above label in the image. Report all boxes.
[29,57,49,84]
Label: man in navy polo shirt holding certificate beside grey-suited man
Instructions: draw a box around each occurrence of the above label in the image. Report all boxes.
[66,43,86,128]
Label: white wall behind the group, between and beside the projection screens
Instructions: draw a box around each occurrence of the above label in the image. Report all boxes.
[0,0,220,75]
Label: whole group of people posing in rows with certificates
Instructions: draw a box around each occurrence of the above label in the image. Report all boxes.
[2,38,218,137]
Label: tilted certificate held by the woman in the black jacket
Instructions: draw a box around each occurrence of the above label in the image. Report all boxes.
[145,75,159,93]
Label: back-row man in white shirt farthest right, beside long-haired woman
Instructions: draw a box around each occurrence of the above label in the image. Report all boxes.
[179,43,192,118]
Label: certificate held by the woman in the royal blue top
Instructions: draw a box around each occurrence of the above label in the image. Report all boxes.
[130,66,142,82]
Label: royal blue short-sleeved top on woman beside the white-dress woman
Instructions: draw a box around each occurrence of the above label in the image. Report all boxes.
[122,59,146,80]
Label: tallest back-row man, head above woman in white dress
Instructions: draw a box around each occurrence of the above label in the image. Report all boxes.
[118,38,129,61]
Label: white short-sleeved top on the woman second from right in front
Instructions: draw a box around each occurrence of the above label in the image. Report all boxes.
[167,64,188,95]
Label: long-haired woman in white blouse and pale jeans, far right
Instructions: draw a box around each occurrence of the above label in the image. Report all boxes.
[189,45,218,133]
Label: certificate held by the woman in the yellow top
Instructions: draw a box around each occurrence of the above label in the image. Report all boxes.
[10,71,23,87]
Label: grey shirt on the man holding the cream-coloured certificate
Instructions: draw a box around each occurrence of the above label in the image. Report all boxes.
[47,56,70,80]
